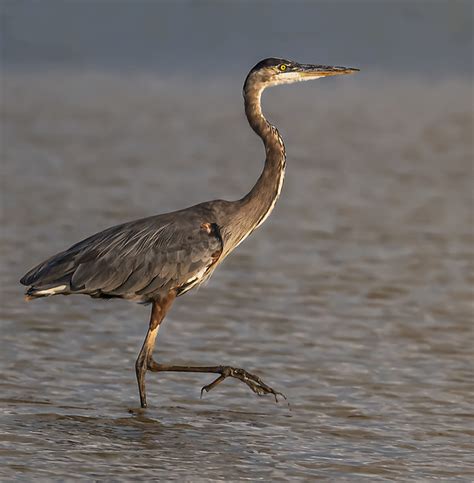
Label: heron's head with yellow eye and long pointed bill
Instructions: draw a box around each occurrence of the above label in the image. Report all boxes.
[244,57,359,90]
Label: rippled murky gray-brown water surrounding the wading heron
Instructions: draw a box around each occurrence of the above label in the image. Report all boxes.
[0,71,474,481]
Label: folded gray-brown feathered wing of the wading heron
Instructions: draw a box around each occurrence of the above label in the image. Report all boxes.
[21,210,223,301]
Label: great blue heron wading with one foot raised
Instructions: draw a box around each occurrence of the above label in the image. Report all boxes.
[21,58,358,408]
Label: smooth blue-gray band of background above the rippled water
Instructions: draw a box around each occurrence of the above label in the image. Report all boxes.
[2,0,473,76]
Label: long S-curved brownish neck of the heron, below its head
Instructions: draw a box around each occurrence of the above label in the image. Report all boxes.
[241,83,286,234]
